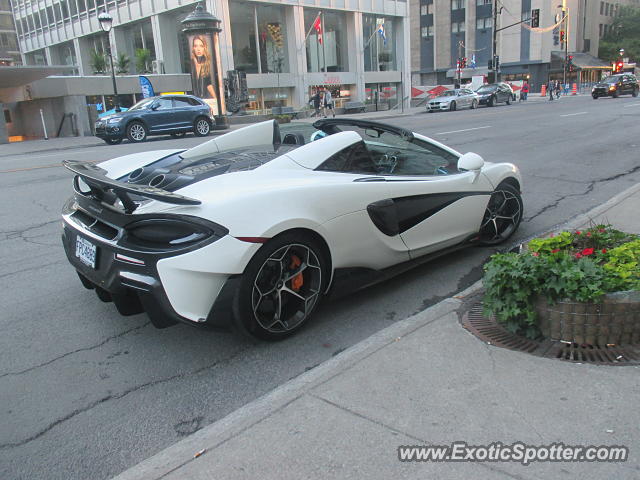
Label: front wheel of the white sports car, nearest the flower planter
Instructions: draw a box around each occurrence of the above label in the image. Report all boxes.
[479,183,523,245]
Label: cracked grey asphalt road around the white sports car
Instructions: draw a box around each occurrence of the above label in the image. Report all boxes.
[0,97,640,480]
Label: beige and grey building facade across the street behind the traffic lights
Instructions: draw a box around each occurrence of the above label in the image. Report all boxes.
[410,0,638,87]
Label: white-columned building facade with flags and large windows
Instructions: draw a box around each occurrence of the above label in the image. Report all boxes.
[13,0,410,112]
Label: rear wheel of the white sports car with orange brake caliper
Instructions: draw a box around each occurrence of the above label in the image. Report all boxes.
[233,232,329,340]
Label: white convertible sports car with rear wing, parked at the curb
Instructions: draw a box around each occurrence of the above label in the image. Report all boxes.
[62,119,523,339]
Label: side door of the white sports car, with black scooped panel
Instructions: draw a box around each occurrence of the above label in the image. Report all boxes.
[363,126,493,257]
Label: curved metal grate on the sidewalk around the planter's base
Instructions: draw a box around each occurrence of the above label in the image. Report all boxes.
[462,302,640,365]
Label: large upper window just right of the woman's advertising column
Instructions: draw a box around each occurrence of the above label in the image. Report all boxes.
[229,2,289,73]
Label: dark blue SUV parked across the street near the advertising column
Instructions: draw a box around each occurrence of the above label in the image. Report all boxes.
[95,95,212,145]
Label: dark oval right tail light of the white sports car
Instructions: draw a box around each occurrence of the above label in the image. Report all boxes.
[122,217,228,250]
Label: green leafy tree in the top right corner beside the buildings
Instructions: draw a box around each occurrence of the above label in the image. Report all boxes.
[598,5,640,63]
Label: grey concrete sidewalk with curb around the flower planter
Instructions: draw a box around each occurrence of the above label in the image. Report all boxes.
[116,184,640,480]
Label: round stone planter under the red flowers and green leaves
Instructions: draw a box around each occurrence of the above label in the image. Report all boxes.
[535,291,640,347]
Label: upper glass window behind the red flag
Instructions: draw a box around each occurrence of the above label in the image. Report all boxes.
[304,8,349,72]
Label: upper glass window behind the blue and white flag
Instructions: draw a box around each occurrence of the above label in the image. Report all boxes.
[362,14,397,72]
